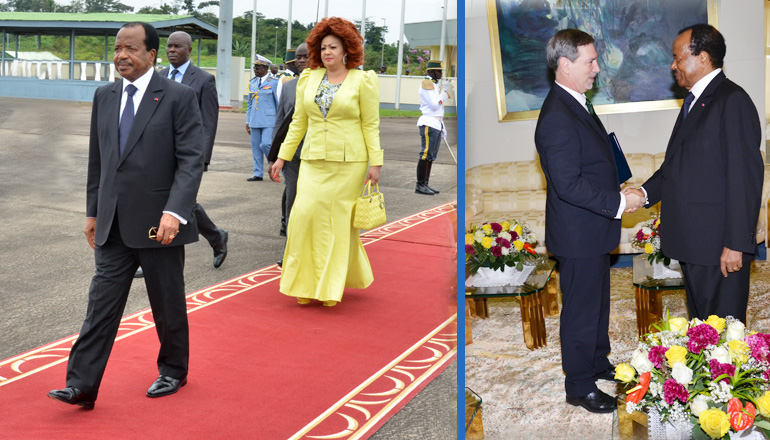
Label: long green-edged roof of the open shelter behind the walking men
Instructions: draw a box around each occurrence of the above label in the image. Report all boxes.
[0,12,217,40]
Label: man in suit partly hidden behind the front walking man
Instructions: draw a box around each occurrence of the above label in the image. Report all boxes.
[160,31,228,268]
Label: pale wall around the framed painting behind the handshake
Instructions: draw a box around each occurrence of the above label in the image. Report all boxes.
[465,0,765,168]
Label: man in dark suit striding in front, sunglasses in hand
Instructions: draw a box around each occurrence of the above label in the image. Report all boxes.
[48,23,203,409]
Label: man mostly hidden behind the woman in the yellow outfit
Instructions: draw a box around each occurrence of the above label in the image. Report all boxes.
[267,42,309,251]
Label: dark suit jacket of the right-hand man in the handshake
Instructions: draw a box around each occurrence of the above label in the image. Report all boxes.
[643,72,764,265]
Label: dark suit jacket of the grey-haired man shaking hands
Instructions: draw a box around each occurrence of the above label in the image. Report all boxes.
[535,84,620,258]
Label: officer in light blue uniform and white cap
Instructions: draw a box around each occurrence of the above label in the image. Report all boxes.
[246,54,278,182]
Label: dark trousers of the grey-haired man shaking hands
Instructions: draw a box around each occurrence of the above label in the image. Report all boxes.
[556,255,610,397]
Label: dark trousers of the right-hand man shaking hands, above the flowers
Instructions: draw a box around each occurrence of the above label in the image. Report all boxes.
[680,253,754,324]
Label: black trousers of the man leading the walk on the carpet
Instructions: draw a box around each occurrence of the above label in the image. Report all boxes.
[67,214,190,397]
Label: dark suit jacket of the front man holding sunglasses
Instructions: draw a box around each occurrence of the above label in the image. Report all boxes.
[86,72,203,248]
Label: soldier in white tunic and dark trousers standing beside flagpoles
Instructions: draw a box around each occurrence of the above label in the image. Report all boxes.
[414,60,452,196]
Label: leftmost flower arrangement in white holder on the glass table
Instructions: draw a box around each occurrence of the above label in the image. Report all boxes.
[465,220,537,287]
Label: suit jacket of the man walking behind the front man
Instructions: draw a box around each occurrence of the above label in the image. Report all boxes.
[160,63,219,165]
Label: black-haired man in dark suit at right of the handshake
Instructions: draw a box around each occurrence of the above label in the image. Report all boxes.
[628,24,764,323]
